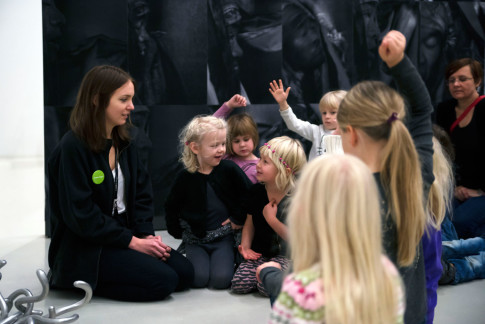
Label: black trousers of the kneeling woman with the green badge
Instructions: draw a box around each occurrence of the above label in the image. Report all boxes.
[94,247,194,301]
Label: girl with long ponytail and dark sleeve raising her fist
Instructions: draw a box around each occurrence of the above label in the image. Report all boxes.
[337,31,434,323]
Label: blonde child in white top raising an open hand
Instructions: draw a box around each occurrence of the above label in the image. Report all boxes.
[269,79,347,160]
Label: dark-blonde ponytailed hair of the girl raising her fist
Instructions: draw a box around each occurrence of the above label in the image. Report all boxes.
[337,81,426,266]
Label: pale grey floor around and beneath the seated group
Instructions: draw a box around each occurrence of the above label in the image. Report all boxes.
[0,158,485,324]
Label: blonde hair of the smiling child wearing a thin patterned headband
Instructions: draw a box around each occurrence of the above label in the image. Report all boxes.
[259,136,306,193]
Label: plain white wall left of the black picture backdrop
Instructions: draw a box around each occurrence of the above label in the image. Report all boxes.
[0,0,44,158]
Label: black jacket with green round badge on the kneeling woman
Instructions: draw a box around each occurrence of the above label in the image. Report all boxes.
[48,131,154,289]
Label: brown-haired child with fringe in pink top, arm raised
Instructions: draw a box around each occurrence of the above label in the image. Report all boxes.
[213,94,259,183]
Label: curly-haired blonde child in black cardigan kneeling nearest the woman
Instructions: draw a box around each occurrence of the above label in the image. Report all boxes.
[165,116,251,289]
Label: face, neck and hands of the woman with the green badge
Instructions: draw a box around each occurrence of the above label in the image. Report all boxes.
[106,81,172,261]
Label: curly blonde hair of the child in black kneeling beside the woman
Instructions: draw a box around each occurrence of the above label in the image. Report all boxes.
[179,115,227,173]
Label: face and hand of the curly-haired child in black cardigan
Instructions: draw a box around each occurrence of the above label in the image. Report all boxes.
[189,129,242,229]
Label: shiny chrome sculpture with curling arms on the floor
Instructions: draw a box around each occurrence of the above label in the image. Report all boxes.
[0,260,93,324]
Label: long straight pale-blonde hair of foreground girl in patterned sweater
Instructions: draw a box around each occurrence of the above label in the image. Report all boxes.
[288,154,400,324]
